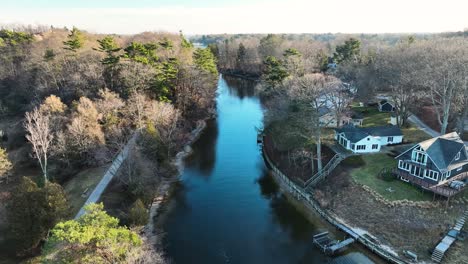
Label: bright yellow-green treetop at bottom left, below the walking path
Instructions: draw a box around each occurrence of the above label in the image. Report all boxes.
[44,203,142,263]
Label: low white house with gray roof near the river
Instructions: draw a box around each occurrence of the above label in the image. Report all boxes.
[335,125,403,153]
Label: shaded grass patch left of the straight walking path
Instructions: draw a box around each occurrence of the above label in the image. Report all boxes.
[64,165,109,216]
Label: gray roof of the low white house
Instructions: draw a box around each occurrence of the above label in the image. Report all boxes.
[335,125,403,143]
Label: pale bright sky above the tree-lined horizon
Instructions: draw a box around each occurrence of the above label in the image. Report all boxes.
[0,0,468,34]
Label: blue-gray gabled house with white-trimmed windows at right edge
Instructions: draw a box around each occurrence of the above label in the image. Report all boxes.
[396,132,468,184]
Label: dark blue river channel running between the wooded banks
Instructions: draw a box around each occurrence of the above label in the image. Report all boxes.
[163,77,376,263]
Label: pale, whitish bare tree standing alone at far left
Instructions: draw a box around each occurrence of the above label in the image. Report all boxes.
[24,107,54,182]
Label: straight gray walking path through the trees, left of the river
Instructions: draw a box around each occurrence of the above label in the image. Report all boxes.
[75,132,138,219]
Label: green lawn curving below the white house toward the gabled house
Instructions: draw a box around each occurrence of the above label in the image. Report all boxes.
[351,154,432,201]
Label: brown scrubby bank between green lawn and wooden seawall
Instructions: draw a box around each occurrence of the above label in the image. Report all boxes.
[313,165,466,261]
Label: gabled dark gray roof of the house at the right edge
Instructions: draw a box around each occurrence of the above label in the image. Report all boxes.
[397,132,467,170]
